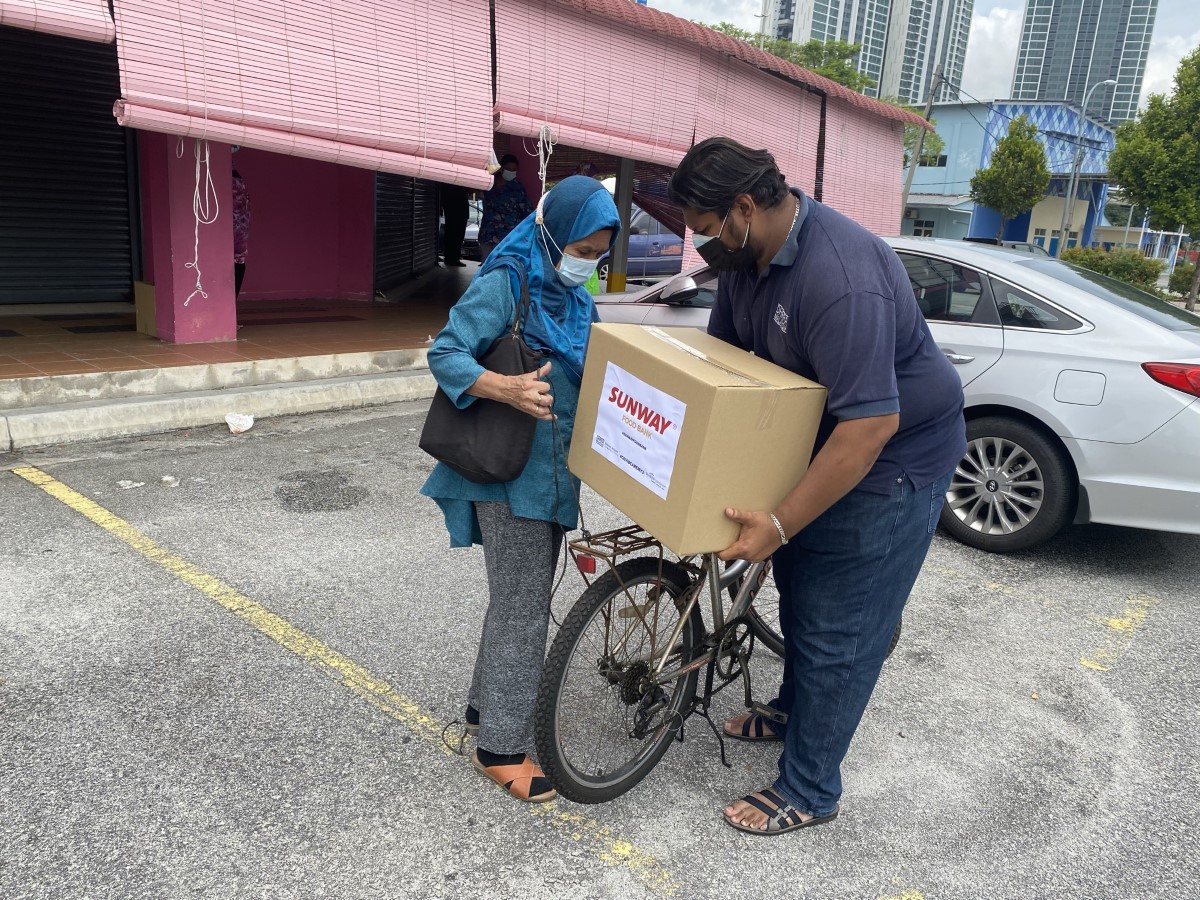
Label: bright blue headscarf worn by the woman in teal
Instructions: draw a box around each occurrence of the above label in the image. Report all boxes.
[479,175,620,384]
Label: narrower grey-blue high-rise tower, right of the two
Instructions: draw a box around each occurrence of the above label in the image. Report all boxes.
[1013,0,1158,122]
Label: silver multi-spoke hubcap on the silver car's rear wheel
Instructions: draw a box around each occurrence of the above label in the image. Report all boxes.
[946,438,1045,534]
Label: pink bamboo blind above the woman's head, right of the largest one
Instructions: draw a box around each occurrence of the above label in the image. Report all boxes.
[496,0,701,166]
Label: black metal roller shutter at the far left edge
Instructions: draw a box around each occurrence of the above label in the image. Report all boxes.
[0,26,136,304]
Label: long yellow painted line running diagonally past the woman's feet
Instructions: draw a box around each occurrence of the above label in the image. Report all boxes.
[12,466,680,896]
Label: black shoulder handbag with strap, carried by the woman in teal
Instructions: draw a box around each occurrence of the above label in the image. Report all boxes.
[420,262,545,485]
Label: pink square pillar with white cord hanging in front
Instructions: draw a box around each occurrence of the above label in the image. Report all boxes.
[138,132,238,343]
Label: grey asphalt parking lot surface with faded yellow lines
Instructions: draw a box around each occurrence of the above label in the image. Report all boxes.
[0,403,1200,900]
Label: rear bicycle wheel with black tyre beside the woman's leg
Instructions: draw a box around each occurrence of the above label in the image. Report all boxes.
[534,557,704,803]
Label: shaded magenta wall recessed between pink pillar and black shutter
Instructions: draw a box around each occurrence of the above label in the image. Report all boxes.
[225,148,374,300]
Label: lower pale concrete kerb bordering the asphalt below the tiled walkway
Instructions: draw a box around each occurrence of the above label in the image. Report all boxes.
[0,368,437,451]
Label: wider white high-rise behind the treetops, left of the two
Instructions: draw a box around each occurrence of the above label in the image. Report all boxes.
[768,0,974,103]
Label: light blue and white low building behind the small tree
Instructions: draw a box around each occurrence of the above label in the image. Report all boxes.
[901,100,1116,253]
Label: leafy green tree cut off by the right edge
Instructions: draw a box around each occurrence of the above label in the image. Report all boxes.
[1109,48,1200,310]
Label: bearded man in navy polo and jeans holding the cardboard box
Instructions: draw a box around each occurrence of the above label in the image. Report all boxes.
[667,138,966,834]
